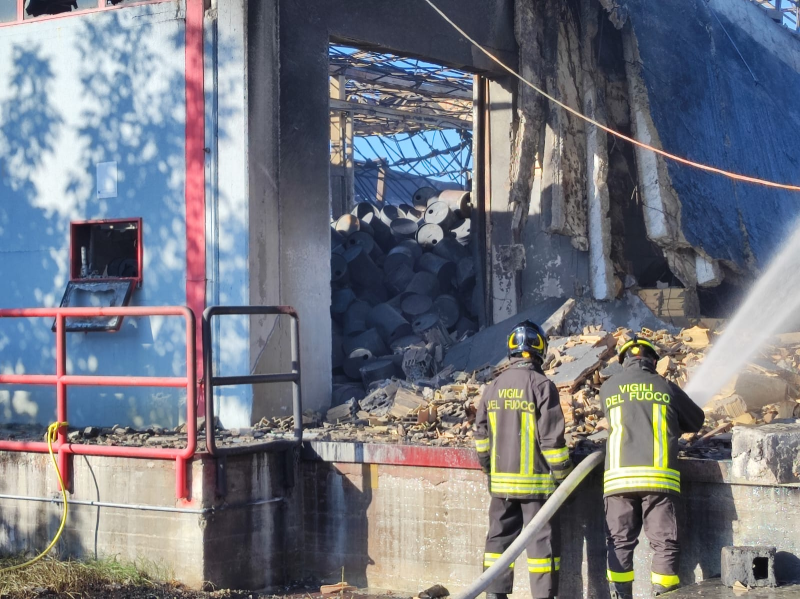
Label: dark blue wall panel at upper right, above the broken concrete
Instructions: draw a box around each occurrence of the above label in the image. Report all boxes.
[627,0,800,268]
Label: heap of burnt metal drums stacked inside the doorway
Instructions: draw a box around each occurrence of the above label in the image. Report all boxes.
[331,187,477,394]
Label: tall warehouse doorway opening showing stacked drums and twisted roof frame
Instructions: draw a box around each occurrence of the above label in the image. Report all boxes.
[329,44,481,406]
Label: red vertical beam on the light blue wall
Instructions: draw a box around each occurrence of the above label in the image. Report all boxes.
[185,0,206,412]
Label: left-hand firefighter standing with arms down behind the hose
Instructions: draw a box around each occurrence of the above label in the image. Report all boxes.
[475,320,572,599]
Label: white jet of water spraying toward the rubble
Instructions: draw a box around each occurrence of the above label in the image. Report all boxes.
[685,228,800,407]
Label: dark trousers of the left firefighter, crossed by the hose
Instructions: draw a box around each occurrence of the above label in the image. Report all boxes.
[483,497,561,599]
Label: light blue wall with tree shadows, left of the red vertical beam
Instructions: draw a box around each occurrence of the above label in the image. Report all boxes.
[0,2,191,426]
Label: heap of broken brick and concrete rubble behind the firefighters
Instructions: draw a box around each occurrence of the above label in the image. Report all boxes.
[307,323,800,459]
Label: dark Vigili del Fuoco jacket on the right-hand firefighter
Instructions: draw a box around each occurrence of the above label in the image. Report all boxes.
[600,358,705,496]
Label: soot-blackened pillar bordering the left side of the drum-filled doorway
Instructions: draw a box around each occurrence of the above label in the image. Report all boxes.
[272,2,331,414]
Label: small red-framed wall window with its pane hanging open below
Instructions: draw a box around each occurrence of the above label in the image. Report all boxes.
[53,218,144,332]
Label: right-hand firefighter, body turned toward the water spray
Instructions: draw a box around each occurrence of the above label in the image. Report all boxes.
[600,336,705,599]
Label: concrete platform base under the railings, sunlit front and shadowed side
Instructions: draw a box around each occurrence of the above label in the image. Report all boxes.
[0,452,302,589]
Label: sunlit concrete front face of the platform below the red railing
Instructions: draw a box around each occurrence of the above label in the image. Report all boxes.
[0,452,213,586]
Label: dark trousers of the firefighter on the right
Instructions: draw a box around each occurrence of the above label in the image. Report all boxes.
[604,492,680,588]
